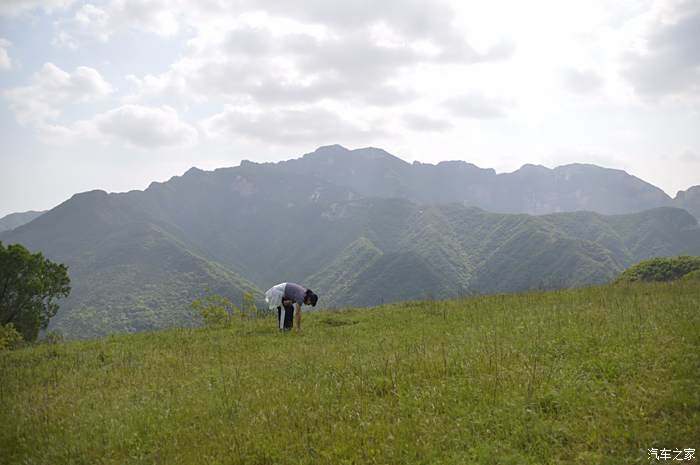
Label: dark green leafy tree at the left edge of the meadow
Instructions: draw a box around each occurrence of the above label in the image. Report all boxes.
[0,242,70,341]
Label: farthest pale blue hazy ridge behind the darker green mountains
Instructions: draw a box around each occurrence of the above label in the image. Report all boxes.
[186,144,700,217]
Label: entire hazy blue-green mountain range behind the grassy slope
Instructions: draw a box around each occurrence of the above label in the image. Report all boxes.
[0,146,700,337]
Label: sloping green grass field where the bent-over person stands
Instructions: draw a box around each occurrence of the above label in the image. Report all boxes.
[0,282,700,465]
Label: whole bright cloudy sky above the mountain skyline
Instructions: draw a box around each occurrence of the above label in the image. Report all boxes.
[0,0,700,216]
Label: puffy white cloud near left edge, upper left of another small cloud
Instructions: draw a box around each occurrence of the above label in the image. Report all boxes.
[4,63,113,126]
